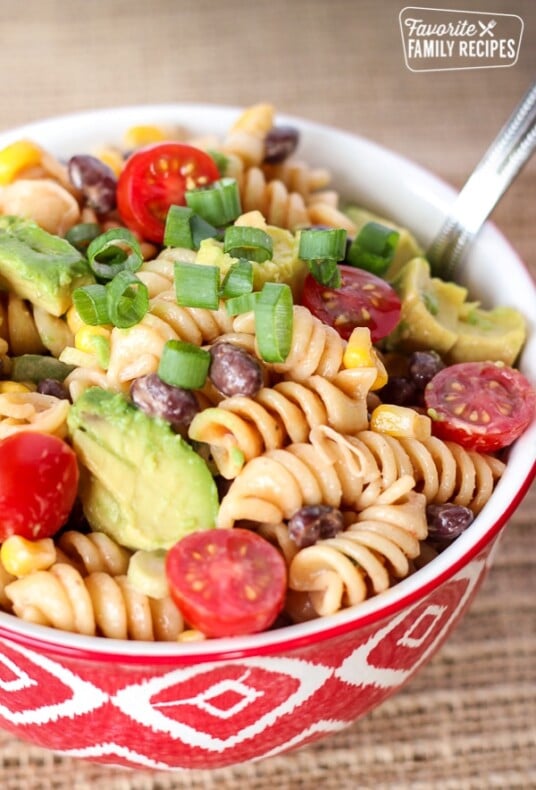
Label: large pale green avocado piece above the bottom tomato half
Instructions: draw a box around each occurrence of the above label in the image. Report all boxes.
[68,387,218,551]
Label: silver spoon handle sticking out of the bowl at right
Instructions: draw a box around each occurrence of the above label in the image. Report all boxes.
[426,83,536,280]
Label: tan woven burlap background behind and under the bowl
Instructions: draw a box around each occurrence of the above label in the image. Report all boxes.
[0,0,536,790]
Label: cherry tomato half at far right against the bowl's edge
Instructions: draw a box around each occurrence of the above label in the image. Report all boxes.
[424,362,536,452]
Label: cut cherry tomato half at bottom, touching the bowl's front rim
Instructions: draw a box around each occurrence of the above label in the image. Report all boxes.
[166,528,287,637]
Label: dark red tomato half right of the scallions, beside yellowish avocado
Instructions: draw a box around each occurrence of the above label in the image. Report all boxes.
[302,265,400,343]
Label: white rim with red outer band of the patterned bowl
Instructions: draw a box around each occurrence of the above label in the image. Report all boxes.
[0,103,536,666]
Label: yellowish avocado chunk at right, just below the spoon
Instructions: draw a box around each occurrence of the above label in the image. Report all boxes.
[385,257,527,365]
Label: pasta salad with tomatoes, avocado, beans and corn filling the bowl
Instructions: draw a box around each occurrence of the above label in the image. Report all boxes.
[0,104,536,641]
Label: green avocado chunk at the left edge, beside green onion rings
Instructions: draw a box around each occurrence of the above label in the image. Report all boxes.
[0,215,95,316]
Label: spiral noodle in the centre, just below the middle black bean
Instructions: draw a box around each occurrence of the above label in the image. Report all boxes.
[188,368,376,479]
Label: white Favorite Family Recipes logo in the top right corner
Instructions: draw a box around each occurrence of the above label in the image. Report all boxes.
[399,6,524,71]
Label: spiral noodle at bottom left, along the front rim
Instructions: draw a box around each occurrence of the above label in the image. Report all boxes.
[4,562,185,641]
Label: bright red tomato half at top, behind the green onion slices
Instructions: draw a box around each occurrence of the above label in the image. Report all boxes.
[117,142,220,244]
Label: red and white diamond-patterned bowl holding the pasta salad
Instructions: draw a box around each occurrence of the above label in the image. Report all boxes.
[0,104,536,770]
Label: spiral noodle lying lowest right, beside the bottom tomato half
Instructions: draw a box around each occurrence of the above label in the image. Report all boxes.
[289,478,427,616]
